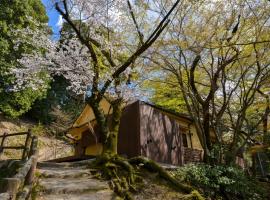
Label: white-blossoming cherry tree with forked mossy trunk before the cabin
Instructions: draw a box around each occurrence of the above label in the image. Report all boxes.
[13,0,180,154]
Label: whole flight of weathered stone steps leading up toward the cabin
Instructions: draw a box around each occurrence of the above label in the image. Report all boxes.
[35,162,116,200]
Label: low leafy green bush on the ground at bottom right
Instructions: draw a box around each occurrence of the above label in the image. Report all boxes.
[175,164,265,200]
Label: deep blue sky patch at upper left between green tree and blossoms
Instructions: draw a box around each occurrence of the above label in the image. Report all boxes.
[42,0,61,34]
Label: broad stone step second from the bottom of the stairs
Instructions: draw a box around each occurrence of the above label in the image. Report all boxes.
[38,177,109,194]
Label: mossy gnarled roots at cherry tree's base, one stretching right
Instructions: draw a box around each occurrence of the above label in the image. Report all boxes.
[91,154,203,200]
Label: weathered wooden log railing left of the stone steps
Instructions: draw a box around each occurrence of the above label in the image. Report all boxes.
[0,130,38,200]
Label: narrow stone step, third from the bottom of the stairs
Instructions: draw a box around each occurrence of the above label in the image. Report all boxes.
[38,168,91,179]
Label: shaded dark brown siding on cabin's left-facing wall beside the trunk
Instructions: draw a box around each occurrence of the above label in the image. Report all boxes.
[118,101,140,157]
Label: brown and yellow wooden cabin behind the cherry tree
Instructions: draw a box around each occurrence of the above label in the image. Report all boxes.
[67,100,211,165]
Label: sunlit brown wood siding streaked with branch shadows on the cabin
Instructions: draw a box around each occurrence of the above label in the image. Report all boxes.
[140,103,183,165]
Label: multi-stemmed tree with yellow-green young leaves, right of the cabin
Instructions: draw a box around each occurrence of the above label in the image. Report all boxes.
[144,0,269,162]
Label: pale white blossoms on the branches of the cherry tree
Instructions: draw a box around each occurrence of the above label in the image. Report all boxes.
[12,0,173,99]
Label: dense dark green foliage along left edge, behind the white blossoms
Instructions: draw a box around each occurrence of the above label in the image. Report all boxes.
[0,0,48,118]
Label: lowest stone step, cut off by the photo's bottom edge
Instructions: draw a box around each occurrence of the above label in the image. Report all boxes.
[37,190,116,200]
